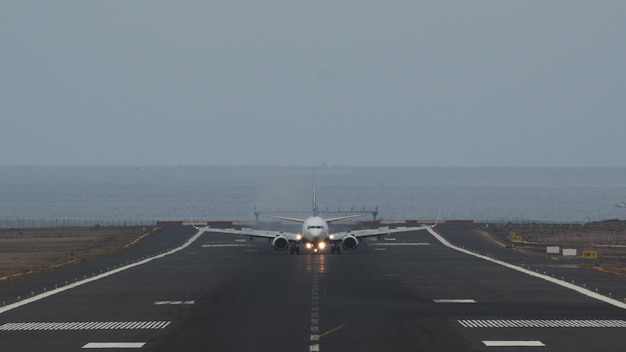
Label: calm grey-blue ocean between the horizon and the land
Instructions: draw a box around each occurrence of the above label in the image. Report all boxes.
[0,166,626,227]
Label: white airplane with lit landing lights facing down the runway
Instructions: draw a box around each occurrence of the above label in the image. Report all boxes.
[192,173,439,254]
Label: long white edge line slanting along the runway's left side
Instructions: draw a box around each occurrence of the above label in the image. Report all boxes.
[0,229,205,314]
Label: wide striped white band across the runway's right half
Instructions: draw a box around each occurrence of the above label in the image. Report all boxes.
[459,319,626,328]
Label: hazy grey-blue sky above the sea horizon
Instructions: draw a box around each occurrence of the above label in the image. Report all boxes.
[0,0,626,166]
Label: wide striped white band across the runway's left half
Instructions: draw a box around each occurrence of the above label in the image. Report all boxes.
[0,321,170,331]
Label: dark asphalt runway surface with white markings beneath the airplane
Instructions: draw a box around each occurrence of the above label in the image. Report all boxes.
[0,224,626,352]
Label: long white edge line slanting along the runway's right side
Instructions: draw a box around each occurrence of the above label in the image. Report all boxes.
[426,227,626,309]
